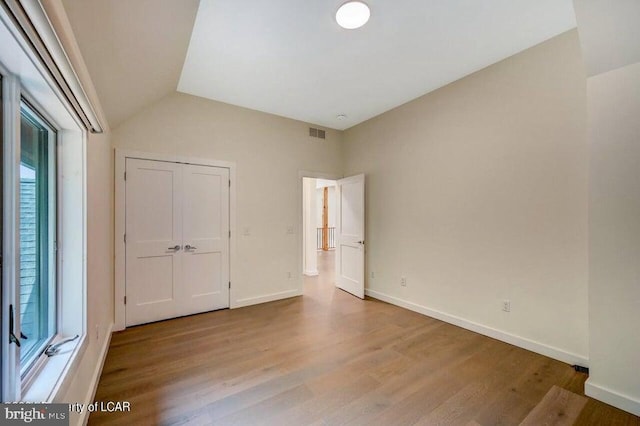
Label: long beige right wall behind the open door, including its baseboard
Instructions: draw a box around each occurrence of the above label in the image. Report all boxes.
[344,30,588,364]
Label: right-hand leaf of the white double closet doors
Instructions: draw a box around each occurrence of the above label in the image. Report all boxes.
[180,165,229,315]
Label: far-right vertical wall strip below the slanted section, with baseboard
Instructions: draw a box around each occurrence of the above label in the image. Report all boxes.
[586,63,640,415]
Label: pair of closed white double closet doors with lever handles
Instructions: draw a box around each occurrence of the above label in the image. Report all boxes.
[125,158,229,326]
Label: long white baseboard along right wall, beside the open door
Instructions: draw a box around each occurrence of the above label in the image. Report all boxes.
[365,289,589,367]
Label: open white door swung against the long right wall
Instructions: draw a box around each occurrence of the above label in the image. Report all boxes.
[336,175,364,299]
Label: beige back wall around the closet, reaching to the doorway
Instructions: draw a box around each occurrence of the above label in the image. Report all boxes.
[113,93,342,306]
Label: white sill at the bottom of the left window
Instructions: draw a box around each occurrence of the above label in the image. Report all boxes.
[22,335,88,402]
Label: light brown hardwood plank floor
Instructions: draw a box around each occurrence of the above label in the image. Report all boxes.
[89,253,640,425]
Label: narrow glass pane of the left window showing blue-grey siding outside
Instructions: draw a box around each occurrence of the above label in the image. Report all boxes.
[19,101,57,377]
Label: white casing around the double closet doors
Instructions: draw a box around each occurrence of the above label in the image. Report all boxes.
[113,148,236,331]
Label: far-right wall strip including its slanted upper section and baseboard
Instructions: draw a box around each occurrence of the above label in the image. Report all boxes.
[574,0,640,415]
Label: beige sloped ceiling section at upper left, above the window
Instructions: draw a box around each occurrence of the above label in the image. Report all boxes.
[63,0,198,127]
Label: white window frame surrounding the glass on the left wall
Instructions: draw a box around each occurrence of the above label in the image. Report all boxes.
[0,7,89,402]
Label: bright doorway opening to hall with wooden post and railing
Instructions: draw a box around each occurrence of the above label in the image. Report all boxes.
[302,177,337,291]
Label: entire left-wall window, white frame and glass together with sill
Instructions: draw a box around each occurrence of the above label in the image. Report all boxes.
[0,2,89,402]
